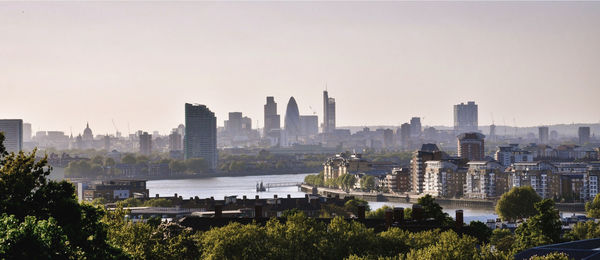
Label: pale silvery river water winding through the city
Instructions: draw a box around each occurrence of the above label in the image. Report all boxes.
[146,174,506,223]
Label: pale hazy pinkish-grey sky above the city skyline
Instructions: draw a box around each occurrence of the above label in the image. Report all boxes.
[0,2,600,134]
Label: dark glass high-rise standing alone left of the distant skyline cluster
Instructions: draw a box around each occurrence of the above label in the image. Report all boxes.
[183,103,218,170]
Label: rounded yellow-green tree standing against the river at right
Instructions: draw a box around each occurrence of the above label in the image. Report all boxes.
[496,186,541,221]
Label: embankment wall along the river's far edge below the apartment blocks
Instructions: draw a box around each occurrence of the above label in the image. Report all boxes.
[300,184,585,213]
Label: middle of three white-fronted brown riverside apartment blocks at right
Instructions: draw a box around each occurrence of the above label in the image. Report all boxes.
[465,161,508,199]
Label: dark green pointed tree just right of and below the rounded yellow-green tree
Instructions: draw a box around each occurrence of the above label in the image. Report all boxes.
[513,199,562,252]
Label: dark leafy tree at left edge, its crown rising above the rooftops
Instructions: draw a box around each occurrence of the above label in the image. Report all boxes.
[0,133,119,259]
